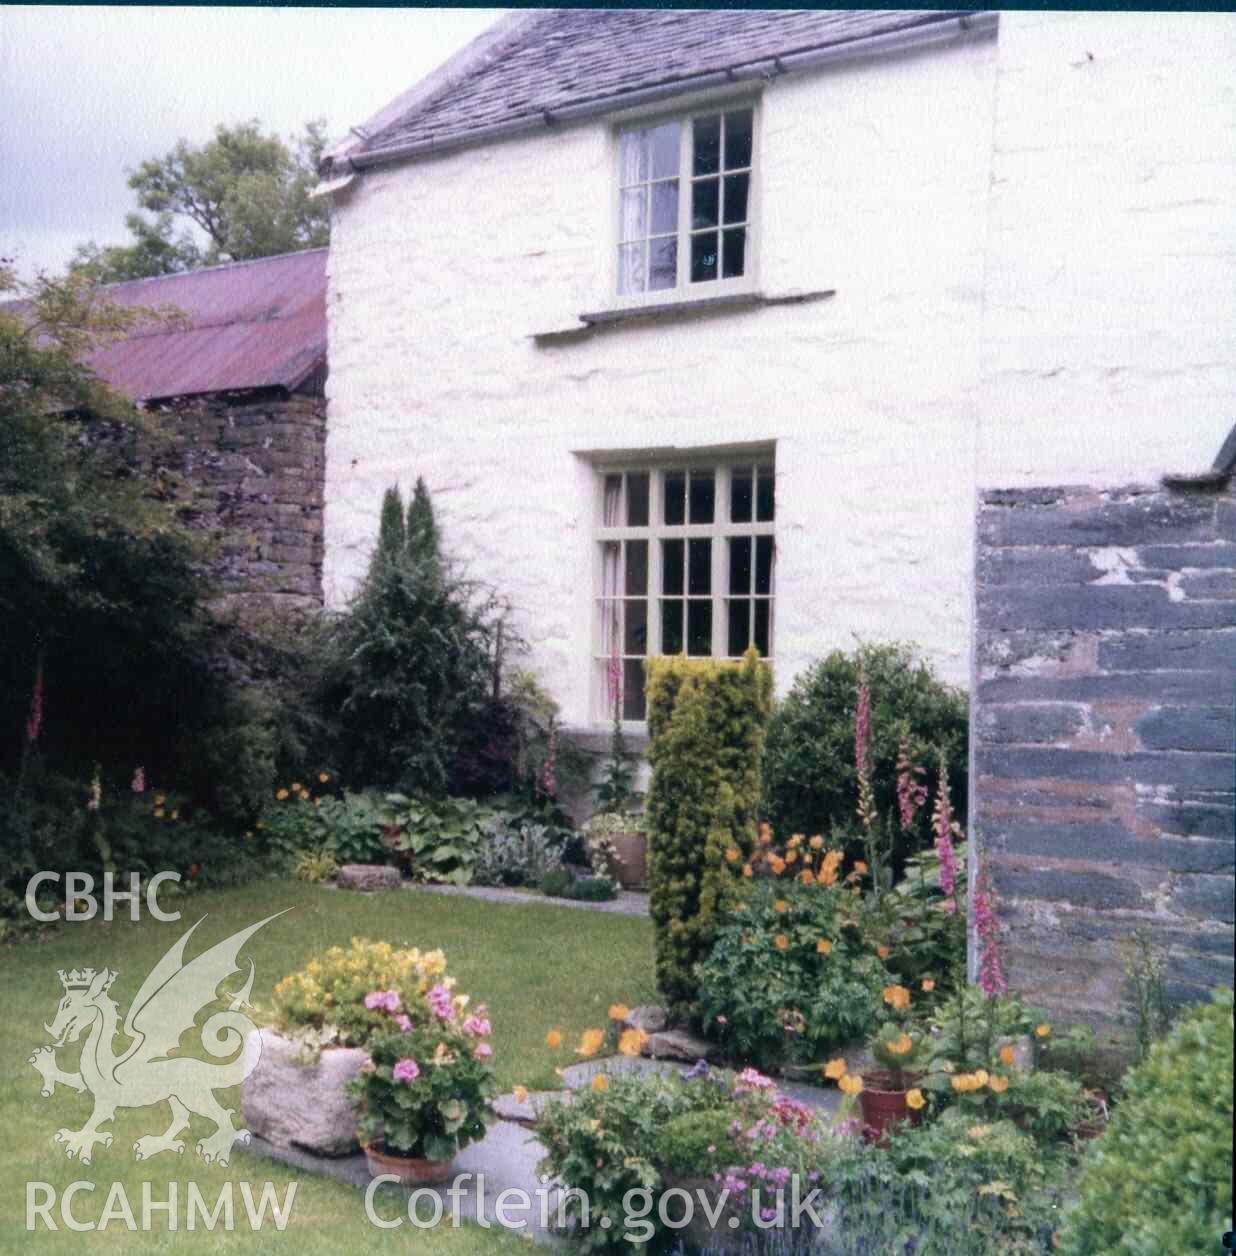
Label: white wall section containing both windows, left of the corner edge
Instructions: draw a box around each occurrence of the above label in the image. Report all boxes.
[324,39,995,726]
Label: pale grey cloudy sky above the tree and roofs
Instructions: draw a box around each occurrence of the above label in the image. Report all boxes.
[0,5,505,274]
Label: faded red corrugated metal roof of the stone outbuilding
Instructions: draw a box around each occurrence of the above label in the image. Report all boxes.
[89,249,327,401]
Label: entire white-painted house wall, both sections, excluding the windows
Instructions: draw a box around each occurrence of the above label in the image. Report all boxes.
[324,14,1236,726]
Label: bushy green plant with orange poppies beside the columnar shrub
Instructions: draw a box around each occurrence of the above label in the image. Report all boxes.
[698,880,891,1068]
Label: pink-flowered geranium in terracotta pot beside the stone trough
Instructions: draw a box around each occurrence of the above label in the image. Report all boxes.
[345,978,497,1183]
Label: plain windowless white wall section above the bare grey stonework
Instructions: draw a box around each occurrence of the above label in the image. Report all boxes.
[979,11,1236,487]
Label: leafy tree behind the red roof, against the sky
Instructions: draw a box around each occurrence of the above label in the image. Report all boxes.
[70,118,330,283]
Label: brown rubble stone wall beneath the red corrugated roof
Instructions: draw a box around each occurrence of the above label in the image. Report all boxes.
[152,389,325,608]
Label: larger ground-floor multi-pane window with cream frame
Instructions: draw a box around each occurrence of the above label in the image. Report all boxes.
[593,455,776,720]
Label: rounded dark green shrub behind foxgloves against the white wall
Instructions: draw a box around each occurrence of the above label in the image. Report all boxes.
[762,644,968,870]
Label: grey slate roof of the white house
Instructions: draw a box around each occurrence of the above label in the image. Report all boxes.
[359,9,975,152]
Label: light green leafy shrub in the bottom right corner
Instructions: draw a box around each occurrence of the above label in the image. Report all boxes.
[1060,990,1233,1256]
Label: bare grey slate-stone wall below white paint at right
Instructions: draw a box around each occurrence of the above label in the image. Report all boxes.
[970,486,1236,1022]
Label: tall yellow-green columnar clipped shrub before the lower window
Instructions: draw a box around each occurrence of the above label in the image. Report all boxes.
[646,649,773,1009]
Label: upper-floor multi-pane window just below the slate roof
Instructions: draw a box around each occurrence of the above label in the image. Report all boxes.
[618,108,755,295]
